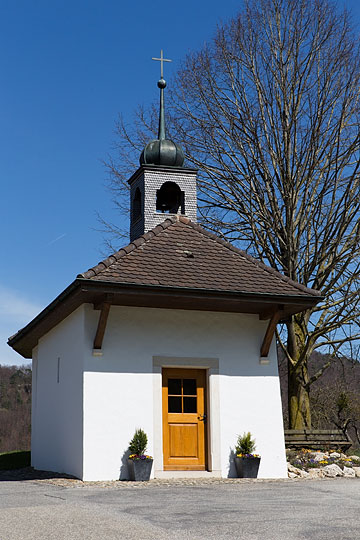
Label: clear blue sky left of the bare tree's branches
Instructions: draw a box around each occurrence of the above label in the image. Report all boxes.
[0,0,360,364]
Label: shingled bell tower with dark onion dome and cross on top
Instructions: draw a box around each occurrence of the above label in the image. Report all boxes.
[129,51,197,242]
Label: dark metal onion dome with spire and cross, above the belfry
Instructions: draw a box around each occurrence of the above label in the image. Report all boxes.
[140,50,184,167]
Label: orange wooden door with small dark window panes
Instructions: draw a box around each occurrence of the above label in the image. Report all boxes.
[162,368,206,471]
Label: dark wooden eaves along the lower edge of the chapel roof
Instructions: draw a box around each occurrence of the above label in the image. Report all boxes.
[8,278,323,358]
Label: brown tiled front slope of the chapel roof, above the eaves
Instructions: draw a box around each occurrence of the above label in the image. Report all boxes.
[78,216,320,297]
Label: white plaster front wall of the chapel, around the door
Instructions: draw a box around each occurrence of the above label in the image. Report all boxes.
[83,305,286,480]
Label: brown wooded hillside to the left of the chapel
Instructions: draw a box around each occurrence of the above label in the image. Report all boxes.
[0,365,31,453]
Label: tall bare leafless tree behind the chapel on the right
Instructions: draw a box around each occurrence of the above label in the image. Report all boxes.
[108,0,360,428]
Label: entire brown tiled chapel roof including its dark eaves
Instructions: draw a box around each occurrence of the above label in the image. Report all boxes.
[8,216,321,358]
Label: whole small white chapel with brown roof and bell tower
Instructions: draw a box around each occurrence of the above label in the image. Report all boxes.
[9,60,319,480]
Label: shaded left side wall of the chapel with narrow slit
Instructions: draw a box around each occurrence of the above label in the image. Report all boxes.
[31,306,84,478]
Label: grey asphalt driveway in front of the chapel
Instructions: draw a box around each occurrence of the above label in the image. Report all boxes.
[0,478,360,540]
